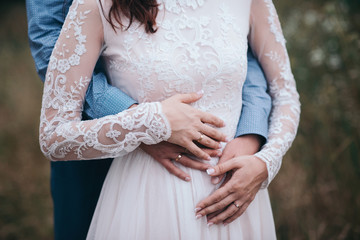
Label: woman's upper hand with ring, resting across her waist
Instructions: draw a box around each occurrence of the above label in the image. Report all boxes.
[161,92,227,159]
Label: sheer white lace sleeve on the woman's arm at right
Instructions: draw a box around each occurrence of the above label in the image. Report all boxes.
[249,0,300,187]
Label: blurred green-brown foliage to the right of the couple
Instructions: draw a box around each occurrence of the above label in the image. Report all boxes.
[270,0,360,239]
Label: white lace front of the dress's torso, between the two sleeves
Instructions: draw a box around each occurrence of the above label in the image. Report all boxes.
[102,0,248,144]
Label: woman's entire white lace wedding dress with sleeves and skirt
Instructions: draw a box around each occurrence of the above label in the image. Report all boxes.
[40,0,300,239]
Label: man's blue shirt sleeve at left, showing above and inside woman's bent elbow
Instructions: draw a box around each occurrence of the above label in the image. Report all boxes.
[26,0,136,119]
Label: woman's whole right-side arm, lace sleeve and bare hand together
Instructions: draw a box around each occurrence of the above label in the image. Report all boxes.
[195,0,300,224]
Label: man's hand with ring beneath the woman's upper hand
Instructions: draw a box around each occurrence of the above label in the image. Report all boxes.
[140,142,221,182]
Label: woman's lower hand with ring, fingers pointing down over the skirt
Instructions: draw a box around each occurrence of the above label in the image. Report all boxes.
[196,155,267,225]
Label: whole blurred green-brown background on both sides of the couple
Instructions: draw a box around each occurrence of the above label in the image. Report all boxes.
[0,0,360,240]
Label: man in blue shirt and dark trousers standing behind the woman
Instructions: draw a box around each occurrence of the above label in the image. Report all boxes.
[26,0,271,240]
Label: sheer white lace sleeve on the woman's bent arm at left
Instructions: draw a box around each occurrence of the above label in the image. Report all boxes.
[39,0,171,160]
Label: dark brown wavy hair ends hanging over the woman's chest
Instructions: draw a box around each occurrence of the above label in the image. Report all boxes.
[100,0,159,33]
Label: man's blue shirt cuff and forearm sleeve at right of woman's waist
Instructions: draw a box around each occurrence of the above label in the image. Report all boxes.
[235,47,271,140]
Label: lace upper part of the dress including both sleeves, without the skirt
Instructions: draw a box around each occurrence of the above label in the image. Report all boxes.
[40,0,299,186]
